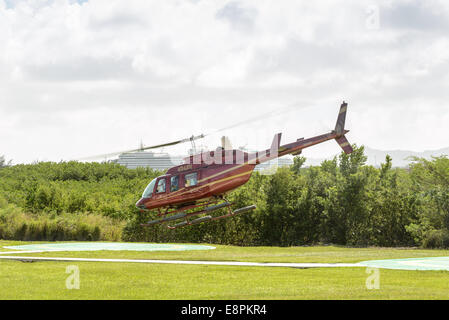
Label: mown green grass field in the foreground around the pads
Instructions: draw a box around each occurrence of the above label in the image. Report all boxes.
[0,241,449,300]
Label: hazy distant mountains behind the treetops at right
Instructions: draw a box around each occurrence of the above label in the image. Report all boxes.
[305,146,449,167]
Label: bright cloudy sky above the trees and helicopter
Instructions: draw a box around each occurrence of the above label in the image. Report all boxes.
[0,0,449,163]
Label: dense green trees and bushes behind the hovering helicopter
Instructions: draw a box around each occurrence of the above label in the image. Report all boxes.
[0,145,449,247]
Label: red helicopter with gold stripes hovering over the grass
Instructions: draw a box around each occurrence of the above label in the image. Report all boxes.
[130,102,353,229]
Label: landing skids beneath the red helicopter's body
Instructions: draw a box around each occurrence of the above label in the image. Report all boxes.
[141,201,256,229]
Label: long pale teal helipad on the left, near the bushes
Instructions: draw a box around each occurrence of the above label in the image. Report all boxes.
[4,242,215,251]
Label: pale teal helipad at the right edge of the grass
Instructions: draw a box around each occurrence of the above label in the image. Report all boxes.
[359,257,449,271]
